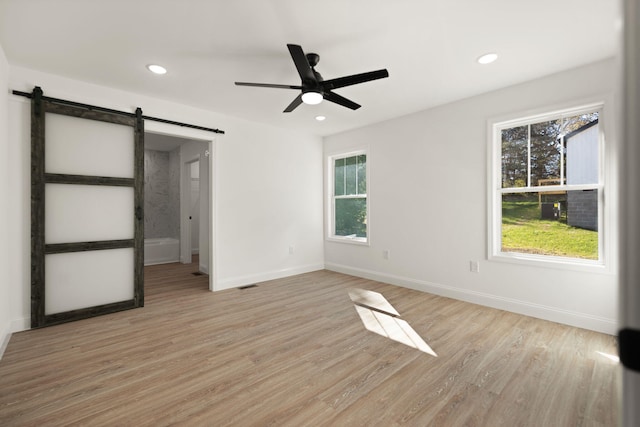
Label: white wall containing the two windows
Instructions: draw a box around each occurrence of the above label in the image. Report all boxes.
[324,60,618,334]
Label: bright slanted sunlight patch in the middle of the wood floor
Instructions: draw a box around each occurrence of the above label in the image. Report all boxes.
[349,289,438,357]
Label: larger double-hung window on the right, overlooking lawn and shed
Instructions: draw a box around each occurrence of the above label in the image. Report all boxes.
[490,105,604,264]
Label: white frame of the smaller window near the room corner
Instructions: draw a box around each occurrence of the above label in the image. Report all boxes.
[327,148,371,246]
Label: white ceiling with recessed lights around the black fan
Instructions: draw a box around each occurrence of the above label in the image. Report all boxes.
[0,0,620,135]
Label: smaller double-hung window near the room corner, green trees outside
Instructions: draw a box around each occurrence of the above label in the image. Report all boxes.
[329,152,368,243]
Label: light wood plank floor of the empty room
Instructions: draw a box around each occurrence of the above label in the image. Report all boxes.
[0,264,619,427]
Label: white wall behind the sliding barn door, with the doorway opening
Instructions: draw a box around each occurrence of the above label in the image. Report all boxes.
[5,66,323,329]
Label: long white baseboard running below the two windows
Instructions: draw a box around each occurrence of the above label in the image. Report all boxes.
[325,263,618,335]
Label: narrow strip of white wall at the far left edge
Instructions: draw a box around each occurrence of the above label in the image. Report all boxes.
[0,46,11,357]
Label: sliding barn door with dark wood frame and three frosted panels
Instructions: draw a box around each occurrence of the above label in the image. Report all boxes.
[31,87,144,328]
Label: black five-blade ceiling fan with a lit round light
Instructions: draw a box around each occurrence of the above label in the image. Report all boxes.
[236,44,389,113]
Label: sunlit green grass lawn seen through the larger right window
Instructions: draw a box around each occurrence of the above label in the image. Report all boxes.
[502,201,598,259]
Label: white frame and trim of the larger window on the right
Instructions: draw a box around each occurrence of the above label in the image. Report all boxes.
[487,102,613,273]
